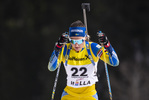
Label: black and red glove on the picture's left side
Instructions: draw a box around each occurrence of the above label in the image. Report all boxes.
[55,32,69,51]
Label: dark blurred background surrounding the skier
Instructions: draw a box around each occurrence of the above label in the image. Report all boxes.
[0,0,149,100]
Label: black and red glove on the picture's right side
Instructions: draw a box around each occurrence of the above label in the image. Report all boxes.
[97,31,110,48]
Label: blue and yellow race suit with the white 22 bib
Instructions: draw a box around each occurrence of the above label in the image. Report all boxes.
[48,41,119,100]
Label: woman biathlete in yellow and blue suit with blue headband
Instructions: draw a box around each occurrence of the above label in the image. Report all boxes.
[48,20,119,100]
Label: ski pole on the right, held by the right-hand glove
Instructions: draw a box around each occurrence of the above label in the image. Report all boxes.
[98,31,112,100]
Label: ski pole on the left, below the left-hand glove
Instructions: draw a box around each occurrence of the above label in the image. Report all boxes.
[51,49,63,100]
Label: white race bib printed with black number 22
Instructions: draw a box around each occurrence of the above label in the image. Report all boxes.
[65,64,98,88]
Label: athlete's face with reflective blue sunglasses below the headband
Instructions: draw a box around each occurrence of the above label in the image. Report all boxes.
[70,37,86,52]
